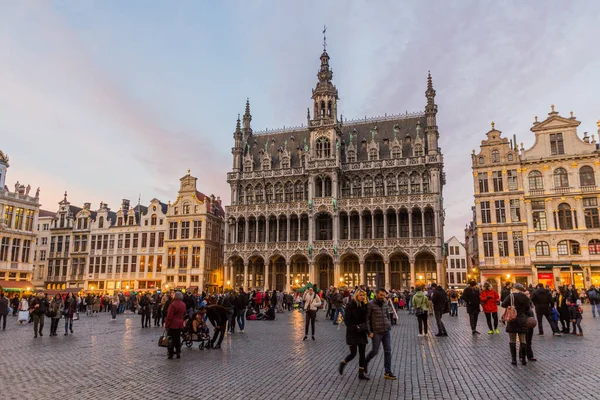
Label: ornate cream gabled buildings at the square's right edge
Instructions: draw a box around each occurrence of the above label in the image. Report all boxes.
[472,106,600,288]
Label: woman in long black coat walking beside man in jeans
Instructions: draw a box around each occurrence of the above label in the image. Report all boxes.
[338,289,370,381]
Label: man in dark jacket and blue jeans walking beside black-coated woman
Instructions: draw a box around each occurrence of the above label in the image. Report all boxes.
[364,288,396,380]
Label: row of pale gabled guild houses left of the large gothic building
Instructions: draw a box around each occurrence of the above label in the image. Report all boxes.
[35,171,224,293]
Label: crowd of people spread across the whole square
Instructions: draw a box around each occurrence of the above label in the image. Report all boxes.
[0,281,600,380]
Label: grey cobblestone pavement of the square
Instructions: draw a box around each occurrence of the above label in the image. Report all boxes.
[0,306,600,400]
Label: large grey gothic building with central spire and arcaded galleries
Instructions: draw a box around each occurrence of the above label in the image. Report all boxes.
[225,47,444,290]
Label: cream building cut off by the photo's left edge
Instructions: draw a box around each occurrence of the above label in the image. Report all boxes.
[0,150,40,291]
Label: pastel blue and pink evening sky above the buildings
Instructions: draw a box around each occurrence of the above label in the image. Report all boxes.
[0,0,600,240]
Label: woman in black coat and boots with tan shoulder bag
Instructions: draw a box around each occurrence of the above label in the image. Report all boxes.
[502,283,530,365]
